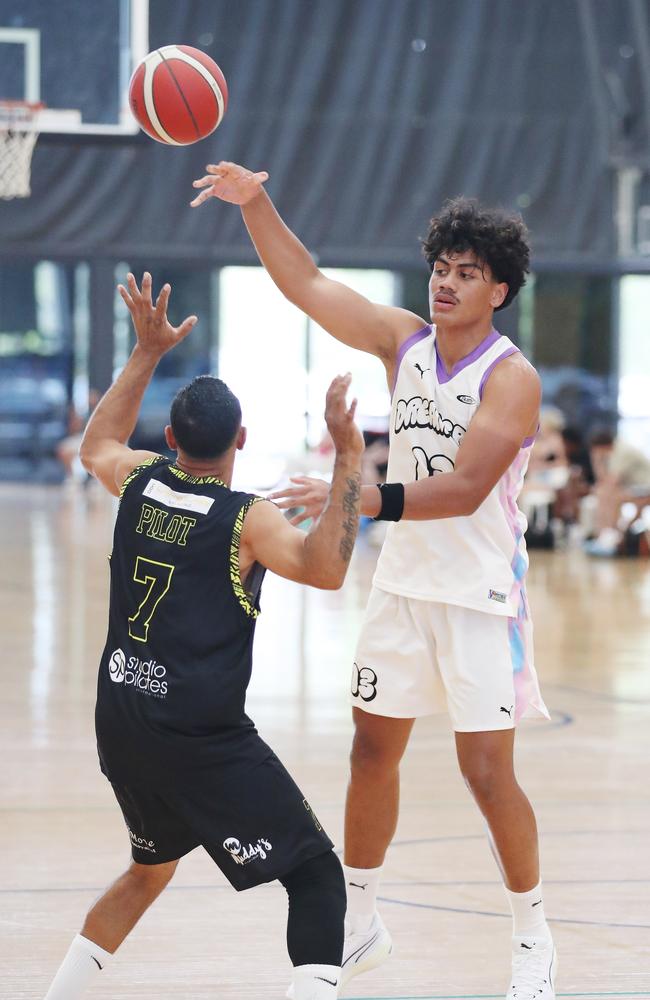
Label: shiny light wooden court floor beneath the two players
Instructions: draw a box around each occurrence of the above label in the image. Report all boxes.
[0,486,650,1000]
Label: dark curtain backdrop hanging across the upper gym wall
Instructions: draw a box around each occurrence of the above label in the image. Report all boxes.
[0,0,650,268]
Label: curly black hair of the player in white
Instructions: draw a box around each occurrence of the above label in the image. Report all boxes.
[422,198,530,310]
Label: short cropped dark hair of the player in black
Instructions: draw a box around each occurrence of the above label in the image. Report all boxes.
[169,375,241,458]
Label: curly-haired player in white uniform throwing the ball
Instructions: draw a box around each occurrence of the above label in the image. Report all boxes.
[192,163,556,1000]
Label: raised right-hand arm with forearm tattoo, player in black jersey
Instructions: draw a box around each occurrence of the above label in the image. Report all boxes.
[239,376,363,590]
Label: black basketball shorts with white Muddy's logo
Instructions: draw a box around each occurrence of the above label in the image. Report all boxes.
[112,753,333,890]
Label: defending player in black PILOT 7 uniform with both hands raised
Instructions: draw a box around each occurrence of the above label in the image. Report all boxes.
[46,273,363,1000]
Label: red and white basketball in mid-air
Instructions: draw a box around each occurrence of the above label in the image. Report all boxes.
[129,45,228,146]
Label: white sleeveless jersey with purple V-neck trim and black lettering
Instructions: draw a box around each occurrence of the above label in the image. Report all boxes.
[373,326,533,618]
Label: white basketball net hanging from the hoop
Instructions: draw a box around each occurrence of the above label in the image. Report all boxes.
[0,101,43,199]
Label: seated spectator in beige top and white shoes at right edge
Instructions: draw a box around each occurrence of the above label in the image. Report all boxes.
[585,429,650,556]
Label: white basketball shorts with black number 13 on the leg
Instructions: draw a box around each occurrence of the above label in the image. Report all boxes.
[351,587,550,732]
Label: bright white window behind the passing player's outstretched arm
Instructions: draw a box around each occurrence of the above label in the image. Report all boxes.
[218,267,392,489]
